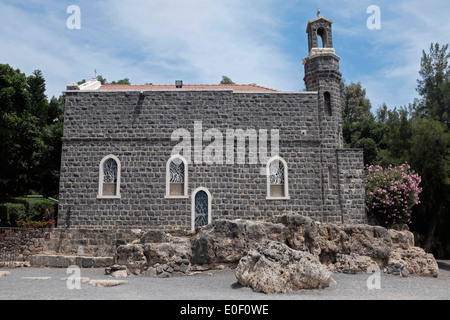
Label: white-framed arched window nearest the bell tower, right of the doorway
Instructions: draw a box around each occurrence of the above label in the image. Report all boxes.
[266,156,289,199]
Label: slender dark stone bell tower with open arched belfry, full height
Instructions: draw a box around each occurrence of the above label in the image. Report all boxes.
[303,13,345,221]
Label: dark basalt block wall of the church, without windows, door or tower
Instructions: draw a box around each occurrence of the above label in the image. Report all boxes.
[59,89,365,230]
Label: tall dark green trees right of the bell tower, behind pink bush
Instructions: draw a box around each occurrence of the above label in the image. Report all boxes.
[341,44,450,258]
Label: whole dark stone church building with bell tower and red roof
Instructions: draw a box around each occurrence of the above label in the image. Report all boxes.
[58,17,366,230]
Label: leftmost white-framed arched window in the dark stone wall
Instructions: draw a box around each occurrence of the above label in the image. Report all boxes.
[97,154,121,198]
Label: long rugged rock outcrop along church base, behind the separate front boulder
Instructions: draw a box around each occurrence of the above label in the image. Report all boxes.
[112,214,438,284]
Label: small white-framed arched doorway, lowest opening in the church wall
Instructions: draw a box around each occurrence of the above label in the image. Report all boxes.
[191,187,212,231]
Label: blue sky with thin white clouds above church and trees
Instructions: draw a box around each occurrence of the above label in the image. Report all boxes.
[0,0,450,112]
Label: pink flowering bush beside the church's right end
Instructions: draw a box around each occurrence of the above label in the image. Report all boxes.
[365,163,422,227]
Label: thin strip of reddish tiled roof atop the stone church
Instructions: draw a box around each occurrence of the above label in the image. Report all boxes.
[98,84,278,92]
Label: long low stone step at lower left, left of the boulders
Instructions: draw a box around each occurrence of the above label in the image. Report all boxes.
[30,254,114,268]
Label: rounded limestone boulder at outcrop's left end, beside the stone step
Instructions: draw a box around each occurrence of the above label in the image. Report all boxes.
[116,244,147,275]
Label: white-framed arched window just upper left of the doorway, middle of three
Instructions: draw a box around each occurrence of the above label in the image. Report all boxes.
[165,154,188,198]
